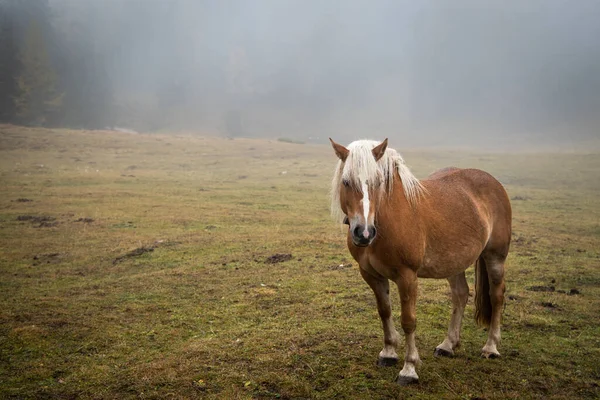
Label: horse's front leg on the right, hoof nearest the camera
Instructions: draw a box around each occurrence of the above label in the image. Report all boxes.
[396,268,421,385]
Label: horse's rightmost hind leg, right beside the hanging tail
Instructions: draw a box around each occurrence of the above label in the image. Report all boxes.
[481,255,505,358]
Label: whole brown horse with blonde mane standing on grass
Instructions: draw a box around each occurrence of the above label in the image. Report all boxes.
[330,139,511,384]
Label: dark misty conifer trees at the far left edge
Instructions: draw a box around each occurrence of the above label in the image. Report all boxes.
[0,0,109,128]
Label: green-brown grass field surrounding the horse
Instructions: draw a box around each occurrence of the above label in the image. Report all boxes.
[0,125,600,399]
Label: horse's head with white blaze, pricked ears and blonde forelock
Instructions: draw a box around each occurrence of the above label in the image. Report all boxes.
[329,139,387,247]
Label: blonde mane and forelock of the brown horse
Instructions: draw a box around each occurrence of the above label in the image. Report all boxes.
[331,140,425,223]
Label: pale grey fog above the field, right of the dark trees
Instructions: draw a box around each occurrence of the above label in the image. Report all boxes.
[0,0,600,149]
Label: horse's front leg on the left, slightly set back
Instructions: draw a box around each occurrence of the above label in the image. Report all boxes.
[360,268,399,367]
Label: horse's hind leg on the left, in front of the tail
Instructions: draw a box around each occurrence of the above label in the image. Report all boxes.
[433,272,469,357]
